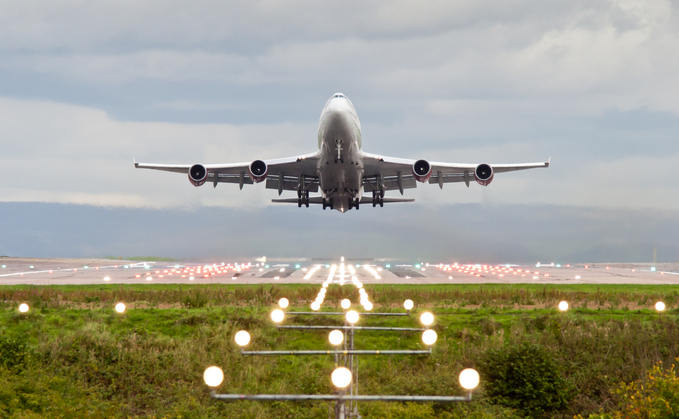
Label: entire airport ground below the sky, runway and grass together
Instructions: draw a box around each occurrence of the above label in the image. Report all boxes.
[0,258,679,418]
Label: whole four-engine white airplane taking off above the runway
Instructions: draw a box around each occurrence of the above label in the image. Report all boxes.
[133,93,551,213]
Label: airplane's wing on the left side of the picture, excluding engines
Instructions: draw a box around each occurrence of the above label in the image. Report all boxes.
[134,152,320,193]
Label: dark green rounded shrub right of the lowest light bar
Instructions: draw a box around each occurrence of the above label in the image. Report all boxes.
[479,343,572,417]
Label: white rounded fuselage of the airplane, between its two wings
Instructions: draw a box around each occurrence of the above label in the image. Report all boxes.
[318,93,363,212]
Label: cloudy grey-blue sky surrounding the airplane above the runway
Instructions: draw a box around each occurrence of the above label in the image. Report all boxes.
[0,0,679,263]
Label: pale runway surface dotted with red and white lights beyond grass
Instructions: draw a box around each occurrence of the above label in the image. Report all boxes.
[0,258,679,285]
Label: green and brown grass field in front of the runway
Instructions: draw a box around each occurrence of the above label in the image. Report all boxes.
[0,284,679,418]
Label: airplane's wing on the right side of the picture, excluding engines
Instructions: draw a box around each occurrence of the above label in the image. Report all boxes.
[363,153,551,194]
